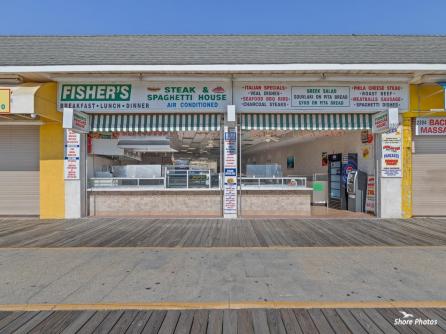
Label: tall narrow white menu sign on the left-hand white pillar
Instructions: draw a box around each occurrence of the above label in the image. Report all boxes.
[64,130,81,180]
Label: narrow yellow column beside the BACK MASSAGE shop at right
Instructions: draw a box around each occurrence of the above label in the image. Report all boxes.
[401,117,412,218]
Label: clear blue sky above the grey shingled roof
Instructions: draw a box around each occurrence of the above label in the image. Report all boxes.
[0,0,446,35]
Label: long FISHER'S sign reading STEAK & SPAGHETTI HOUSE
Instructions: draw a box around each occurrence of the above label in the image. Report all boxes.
[57,81,231,113]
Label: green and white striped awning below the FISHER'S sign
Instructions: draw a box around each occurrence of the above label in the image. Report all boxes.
[91,114,221,132]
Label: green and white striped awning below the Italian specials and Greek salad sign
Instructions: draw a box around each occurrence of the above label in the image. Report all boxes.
[242,114,372,130]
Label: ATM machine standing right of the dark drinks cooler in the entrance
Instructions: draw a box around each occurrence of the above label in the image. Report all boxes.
[347,170,367,212]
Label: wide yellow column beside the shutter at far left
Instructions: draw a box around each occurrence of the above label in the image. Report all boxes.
[40,123,65,219]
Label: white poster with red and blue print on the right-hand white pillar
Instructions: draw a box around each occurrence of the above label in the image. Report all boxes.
[381,127,402,177]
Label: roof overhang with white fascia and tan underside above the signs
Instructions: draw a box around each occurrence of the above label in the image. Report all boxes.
[0,64,446,84]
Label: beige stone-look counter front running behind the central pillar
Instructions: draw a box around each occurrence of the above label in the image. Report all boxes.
[88,187,312,218]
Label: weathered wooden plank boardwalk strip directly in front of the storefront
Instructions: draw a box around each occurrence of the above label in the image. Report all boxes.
[0,218,446,247]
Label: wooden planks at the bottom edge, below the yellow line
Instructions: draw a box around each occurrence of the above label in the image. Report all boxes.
[0,309,446,334]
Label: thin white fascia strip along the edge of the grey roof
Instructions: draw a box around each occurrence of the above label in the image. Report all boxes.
[0,64,446,73]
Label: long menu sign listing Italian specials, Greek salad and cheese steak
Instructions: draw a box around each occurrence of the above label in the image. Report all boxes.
[234,82,409,112]
